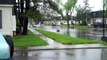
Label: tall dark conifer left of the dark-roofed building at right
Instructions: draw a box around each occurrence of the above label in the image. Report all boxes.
[76,0,91,25]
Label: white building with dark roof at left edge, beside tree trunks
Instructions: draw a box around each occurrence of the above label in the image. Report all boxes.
[0,0,16,36]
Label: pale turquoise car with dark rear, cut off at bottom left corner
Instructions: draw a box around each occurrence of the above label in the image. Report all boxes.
[0,33,14,60]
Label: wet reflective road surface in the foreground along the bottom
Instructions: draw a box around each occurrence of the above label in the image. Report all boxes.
[13,49,107,60]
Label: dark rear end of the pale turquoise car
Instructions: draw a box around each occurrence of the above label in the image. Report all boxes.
[4,35,14,57]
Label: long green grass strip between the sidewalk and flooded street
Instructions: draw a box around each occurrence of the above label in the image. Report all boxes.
[37,29,98,45]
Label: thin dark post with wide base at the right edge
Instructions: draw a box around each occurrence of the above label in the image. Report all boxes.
[101,0,107,42]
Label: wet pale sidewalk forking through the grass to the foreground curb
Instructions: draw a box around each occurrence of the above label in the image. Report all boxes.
[15,28,107,51]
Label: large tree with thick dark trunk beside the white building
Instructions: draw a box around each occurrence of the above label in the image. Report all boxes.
[14,0,61,35]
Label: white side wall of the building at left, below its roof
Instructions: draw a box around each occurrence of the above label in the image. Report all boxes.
[0,5,13,36]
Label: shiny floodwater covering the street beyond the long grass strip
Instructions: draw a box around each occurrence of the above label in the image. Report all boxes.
[41,26,107,41]
